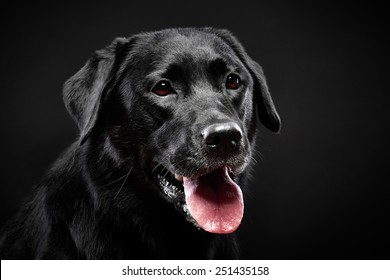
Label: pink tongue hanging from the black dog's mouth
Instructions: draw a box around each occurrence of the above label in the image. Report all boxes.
[183,167,244,233]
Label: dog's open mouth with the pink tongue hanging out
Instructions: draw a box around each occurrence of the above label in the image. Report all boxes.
[153,165,244,234]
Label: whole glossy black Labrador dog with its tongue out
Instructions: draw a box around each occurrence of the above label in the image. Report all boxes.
[1,28,280,259]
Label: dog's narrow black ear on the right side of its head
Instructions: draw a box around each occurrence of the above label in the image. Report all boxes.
[206,28,281,132]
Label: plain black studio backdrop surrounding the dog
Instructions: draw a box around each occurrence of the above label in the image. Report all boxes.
[0,0,390,259]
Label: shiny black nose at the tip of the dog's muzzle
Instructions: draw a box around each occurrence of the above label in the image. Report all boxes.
[202,122,242,153]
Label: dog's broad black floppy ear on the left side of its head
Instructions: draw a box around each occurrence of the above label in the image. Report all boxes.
[63,38,130,145]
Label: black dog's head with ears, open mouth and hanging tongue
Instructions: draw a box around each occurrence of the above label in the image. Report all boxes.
[64,28,280,233]
